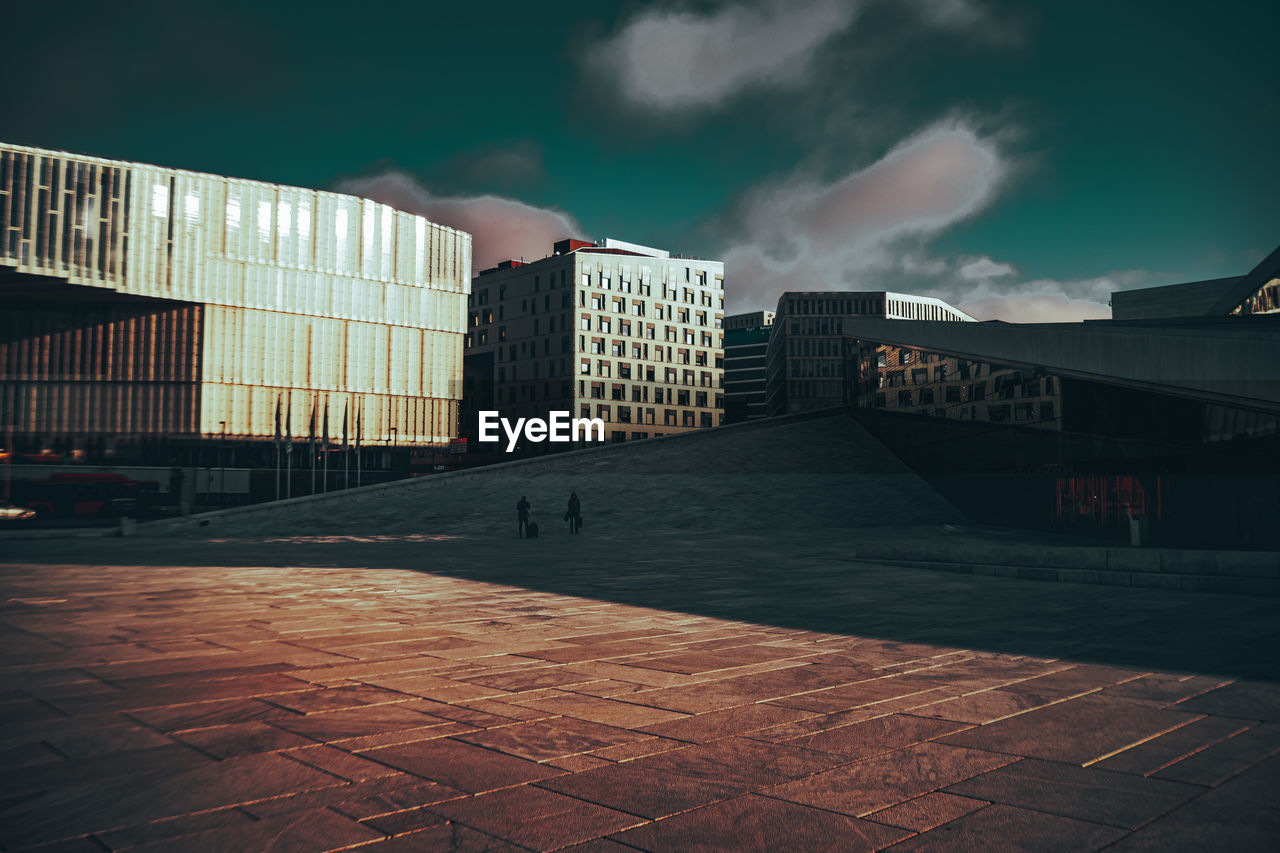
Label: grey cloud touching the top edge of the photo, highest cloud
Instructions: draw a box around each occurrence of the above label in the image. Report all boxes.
[586,0,861,109]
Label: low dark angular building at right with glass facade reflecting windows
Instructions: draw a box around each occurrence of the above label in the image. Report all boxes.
[844,242,1280,548]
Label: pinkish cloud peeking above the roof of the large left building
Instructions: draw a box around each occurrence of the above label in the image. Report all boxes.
[335,172,582,272]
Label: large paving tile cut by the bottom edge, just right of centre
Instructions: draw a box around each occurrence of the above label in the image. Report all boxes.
[613,794,910,853]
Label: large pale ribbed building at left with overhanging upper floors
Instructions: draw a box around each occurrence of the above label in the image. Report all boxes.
[0,145,471,500]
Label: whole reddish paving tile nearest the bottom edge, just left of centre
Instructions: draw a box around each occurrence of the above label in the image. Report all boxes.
[430,785,645,850]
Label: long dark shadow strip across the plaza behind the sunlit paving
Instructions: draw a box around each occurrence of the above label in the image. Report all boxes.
[0,528,1280,681]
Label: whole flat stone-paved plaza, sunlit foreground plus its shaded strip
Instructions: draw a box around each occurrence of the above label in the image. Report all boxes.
[0,525,1280,850]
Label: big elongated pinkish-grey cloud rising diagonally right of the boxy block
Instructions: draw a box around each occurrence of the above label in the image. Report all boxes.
[724,122,1009,311]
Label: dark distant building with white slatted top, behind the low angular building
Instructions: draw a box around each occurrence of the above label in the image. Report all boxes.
[765,291,973,415]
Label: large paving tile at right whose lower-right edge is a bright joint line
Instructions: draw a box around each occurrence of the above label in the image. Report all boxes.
[943,694,1198,765]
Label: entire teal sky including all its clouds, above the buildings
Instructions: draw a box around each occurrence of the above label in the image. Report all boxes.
[0,0,1280,321]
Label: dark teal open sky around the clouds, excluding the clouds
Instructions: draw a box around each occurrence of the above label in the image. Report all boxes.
[0,1,1280,312]
